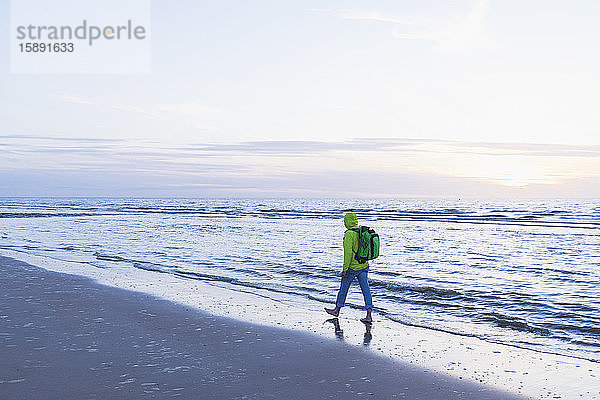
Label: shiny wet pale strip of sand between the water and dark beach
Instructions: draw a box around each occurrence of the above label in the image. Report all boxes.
[0,250,600,399]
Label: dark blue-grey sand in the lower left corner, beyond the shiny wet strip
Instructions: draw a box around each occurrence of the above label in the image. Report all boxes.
[0,257,521,399]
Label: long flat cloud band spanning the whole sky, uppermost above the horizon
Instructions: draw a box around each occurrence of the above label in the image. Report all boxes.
[0,134,600,157]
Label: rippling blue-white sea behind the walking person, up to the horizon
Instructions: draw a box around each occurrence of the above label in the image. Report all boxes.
[0,198,600,362]
